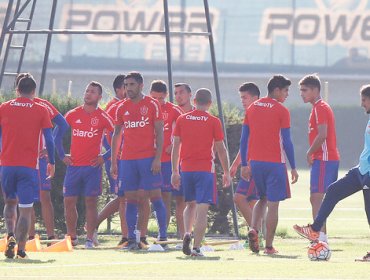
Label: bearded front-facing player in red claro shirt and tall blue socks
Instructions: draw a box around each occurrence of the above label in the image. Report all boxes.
[111,72,167,250]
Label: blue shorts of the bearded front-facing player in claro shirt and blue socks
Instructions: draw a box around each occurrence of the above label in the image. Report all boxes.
[118,157,162,196]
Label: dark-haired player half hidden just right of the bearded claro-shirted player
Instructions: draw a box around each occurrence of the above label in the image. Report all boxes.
[150,80,184,234]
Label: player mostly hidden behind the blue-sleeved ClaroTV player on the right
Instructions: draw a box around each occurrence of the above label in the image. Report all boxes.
[230,82,260,226]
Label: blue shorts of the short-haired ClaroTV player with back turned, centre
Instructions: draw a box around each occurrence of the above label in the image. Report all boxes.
[181,172,217,204]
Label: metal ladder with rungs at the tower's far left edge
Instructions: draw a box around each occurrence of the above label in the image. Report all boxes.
[0,0,37,87]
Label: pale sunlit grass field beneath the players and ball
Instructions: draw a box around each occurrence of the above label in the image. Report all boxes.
[0,172,370,280]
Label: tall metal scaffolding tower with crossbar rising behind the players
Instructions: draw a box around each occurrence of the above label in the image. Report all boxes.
[0,0,239,236]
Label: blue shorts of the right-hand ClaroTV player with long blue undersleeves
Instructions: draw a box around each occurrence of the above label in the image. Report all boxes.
[251,160,290,201]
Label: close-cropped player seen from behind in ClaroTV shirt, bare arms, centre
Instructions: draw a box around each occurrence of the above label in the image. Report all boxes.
[171,88,230,256]
